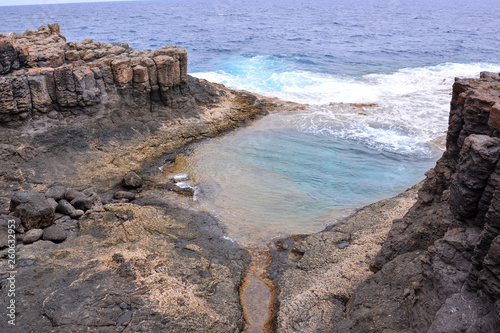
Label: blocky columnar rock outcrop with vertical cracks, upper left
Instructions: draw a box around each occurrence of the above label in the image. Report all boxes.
[0,23,194,126]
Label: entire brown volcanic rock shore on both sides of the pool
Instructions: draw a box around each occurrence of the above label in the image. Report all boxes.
[0,24,500,333]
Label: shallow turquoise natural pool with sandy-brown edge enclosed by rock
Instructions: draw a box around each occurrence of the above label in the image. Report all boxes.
[166,108,439,245]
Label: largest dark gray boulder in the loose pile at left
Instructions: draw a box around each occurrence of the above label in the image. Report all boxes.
[10,192,55,230]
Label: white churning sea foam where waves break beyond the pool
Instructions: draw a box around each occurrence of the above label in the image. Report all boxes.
[193,61,500,153]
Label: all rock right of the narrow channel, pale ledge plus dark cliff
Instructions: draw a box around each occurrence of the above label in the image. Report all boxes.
[268,73,500,333]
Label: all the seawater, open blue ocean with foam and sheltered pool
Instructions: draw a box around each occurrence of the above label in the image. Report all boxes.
[0,0,500,242]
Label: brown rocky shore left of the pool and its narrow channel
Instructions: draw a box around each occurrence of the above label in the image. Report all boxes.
[0,24,273,332]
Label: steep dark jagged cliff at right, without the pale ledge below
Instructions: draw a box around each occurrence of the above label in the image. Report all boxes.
[337,73,500,333]
